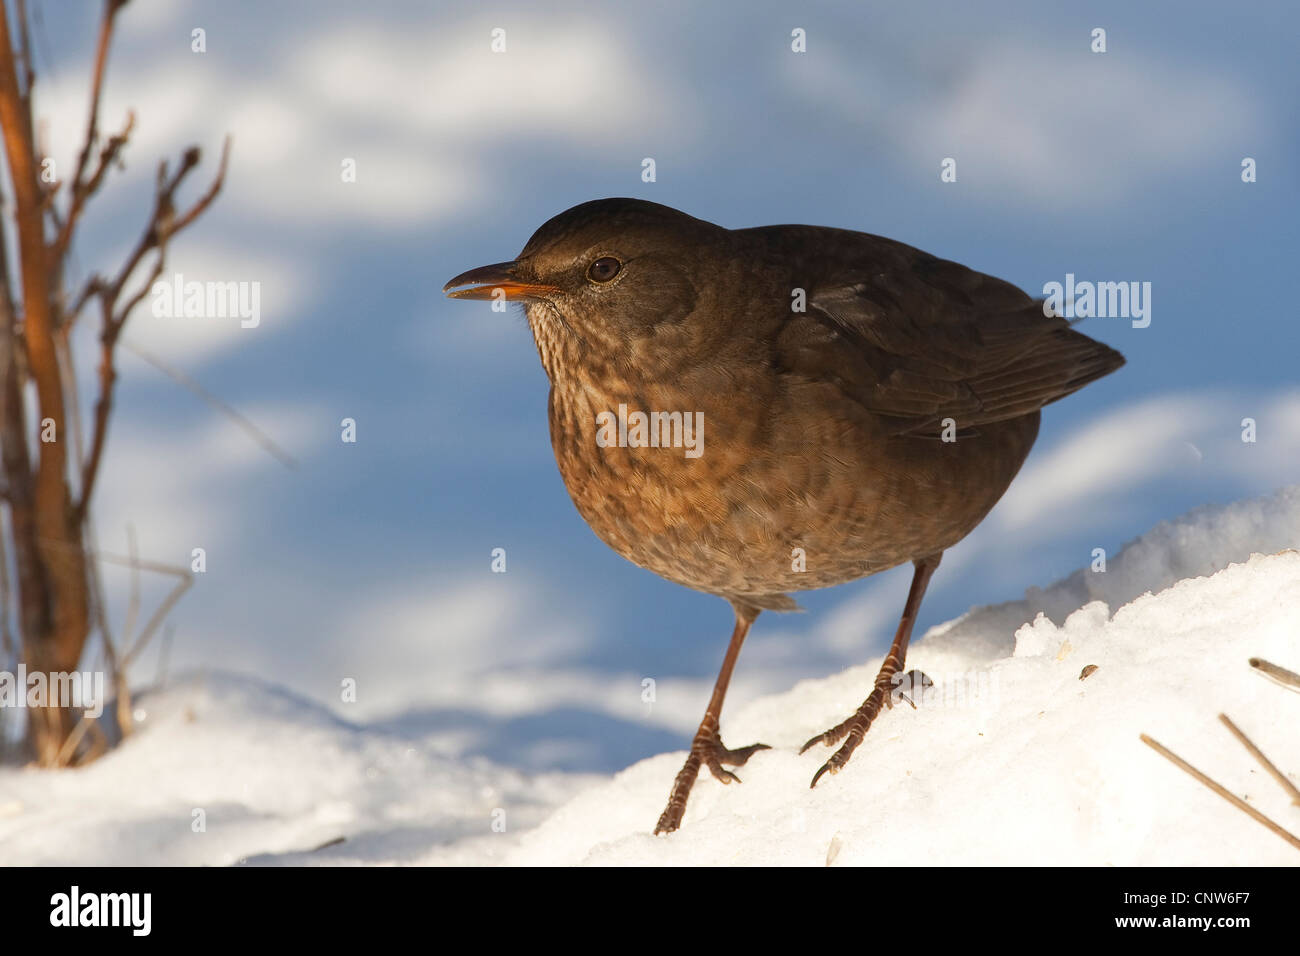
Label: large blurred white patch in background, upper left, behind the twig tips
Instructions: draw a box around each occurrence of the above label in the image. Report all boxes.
[38,14,693,234]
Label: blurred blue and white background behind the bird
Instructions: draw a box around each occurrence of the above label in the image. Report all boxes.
[27,0,1300,769]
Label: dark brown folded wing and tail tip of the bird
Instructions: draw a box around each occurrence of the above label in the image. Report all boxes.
[769,235,1125,434]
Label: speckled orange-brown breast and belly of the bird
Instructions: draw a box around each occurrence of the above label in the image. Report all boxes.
[550,369,1037,609]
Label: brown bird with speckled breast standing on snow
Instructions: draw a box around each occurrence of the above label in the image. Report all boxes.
[443,198,1125,834]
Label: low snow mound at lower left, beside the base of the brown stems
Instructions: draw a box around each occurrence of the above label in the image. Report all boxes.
[0,674,595,866]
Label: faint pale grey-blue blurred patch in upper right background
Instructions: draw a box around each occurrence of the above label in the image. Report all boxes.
[787,38,1268,209]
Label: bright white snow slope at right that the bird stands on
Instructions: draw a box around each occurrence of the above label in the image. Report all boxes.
[478,488,1300,866]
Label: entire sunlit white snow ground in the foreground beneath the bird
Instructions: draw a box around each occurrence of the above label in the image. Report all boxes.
[0,486,1300,866]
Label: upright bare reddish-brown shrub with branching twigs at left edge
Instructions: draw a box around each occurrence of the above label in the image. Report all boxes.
[0,0,223,765]
